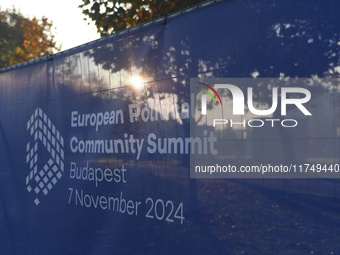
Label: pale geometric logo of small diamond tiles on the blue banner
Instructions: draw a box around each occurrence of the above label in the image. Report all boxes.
[26,108,64,205]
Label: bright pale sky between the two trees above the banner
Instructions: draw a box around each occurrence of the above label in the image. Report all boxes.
[0,0,100,51]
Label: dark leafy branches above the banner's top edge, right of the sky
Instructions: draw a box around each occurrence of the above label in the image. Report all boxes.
[79,0,205,36]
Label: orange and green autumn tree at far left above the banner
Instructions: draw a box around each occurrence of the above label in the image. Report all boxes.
[0,9,60,68]
